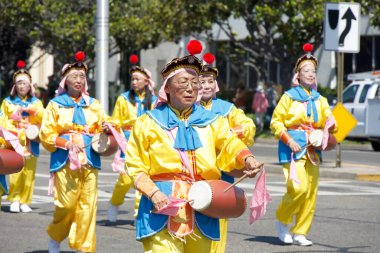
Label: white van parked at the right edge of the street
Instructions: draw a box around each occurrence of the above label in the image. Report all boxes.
[343,70,380,151]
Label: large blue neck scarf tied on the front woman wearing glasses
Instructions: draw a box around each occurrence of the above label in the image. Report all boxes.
[147,104,219,151]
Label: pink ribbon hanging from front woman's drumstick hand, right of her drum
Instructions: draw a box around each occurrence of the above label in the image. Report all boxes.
[249,168,272,224]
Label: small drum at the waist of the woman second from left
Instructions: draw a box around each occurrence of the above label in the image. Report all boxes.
[91,133,119,156]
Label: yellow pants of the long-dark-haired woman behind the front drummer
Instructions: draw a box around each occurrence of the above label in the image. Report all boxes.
[110,173,141,217]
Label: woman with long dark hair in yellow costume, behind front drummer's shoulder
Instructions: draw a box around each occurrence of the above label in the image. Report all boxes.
[107,55,157,222]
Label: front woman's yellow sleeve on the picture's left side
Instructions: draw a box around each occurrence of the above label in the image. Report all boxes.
[125,114,153,179]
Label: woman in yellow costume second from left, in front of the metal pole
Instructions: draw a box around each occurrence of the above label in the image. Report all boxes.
[40,51,117,253]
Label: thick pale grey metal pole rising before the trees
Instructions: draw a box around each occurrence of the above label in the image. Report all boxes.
[95,0,109,113]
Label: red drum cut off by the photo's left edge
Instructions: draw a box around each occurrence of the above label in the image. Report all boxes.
[0,149,24,175]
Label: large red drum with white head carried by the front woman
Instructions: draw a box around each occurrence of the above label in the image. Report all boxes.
[187,180,247,218]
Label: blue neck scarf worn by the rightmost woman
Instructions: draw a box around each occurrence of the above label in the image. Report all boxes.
[285,85,321,123]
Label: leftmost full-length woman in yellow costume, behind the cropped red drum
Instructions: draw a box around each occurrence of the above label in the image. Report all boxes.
[1,61,44,213]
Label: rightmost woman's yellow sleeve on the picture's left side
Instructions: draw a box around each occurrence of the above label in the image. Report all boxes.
[270,95,292,139]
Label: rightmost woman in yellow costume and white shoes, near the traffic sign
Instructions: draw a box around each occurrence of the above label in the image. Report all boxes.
[271,44,337,246]
